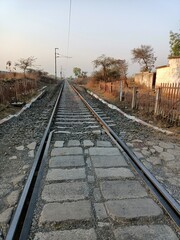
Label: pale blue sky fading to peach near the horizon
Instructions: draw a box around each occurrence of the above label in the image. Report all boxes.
[0,0,180,77]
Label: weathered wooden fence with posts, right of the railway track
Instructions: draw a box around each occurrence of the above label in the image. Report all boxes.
[99,81,180,126]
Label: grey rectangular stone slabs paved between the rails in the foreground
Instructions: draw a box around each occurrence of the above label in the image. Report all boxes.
[34,139,178,240]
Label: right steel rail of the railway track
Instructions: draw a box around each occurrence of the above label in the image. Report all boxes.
[71,86,180,226]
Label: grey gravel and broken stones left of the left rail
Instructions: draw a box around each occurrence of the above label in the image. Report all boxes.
[0,84,58,236]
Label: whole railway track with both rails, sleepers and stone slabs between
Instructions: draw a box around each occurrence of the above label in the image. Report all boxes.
[6,82,180,240]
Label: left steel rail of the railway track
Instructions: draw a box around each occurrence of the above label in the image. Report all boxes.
[6,83,64,240]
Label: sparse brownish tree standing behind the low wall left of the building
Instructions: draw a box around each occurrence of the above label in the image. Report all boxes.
[131,45,157,72]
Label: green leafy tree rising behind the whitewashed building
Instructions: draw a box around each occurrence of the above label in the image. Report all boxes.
[169,31,180,57]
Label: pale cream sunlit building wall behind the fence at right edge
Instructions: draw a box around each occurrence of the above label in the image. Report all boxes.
[156,57,180,86]
